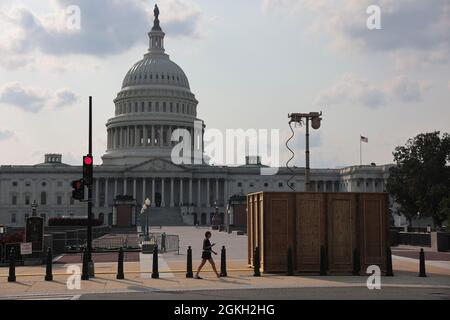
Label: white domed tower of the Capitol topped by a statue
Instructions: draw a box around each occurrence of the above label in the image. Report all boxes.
[103,6,204,166]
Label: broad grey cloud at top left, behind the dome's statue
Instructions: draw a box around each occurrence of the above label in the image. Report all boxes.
[0,0,203,69]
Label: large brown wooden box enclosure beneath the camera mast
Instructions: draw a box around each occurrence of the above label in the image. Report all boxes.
[247,192,389,274]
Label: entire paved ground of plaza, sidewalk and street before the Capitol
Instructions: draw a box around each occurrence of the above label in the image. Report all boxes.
[0,227,450,300]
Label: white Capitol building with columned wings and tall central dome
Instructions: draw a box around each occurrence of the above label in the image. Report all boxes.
[0,7,398,227]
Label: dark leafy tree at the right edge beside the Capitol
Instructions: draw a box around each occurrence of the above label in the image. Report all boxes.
[386,132,450,227]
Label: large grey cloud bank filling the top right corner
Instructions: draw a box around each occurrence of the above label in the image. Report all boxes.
[261,0,450,63]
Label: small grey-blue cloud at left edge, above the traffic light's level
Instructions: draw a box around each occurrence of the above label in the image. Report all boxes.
[0,82,78,113]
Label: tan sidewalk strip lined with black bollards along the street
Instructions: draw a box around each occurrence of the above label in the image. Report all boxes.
[0,256,450,299]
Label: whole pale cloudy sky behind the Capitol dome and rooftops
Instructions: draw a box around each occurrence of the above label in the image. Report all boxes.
[0,0,450,168]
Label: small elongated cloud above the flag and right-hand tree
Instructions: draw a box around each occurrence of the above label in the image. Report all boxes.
[316,74,430,109]
